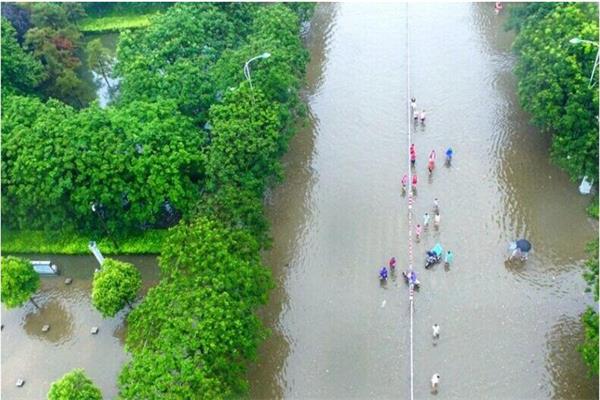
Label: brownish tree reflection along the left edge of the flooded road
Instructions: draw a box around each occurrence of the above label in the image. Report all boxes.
[249,4,337,399]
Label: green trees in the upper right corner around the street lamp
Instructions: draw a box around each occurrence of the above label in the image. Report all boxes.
[514,3,598,181]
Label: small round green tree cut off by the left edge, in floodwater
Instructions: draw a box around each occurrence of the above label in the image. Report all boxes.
[1,256,40,308]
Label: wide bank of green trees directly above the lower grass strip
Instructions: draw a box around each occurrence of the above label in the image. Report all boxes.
[2,96,201,231]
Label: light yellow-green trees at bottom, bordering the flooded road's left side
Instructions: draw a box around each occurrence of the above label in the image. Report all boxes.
[119,218,272,399]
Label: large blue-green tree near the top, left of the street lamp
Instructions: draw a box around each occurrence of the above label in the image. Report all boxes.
[115,3,241,120]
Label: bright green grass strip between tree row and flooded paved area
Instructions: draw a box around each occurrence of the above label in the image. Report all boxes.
[1,229,168,254]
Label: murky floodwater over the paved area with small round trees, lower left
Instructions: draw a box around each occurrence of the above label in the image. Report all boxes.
[1,254,159,400]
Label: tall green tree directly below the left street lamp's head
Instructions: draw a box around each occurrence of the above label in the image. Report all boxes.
[200,83,287,243]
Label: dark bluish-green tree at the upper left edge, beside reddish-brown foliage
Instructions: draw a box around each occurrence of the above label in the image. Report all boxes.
[0,18,43,95]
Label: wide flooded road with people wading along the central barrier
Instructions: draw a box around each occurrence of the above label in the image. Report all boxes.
[250,3,598,399]
